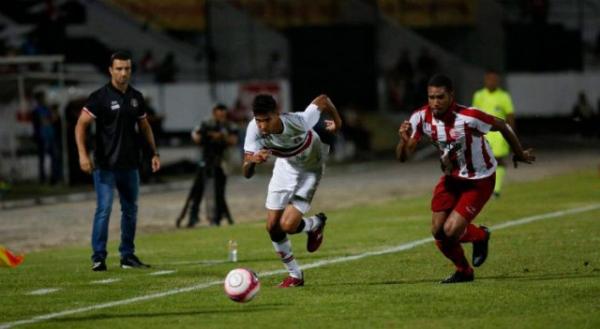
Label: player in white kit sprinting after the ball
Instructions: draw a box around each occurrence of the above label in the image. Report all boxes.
[243,95,342,288]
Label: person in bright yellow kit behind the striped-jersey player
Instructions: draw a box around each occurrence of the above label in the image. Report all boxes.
[473,70,515,198]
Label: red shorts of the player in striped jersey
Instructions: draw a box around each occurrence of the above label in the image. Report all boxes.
[431,174,496,222]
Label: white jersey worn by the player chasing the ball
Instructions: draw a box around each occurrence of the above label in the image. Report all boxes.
[244,104,329,170]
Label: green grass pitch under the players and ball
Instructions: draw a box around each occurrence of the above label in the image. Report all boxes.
[0,170,600,329]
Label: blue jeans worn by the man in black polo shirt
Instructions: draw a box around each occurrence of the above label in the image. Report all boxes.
[92,169,140,261]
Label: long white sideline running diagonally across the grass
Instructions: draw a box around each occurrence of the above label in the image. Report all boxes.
[0,204,600,329]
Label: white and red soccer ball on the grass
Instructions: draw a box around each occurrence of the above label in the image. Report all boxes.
[223,268,260,303]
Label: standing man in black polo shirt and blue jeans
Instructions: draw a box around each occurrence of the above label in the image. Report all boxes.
[75,52,160,271]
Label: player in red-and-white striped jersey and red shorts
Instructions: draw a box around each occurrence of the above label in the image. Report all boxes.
[396,75,535,283]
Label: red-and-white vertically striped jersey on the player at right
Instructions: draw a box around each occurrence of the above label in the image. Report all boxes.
[410,103,497,179]
